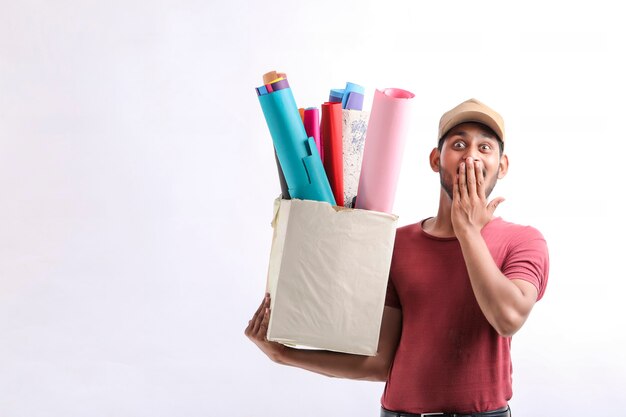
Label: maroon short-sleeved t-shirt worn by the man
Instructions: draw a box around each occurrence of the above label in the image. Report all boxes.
[382,218,549,413]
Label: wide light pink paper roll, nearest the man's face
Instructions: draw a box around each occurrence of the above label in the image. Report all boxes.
[356,88,415,213]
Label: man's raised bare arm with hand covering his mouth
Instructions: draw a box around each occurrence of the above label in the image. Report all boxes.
[452,160,537,336]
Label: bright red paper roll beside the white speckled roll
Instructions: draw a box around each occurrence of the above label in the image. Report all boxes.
[320,103,343,206]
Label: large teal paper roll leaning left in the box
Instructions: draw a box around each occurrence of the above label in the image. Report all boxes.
[258,83,336,205]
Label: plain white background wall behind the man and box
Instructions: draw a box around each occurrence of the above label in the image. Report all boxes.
[0,0,626,417]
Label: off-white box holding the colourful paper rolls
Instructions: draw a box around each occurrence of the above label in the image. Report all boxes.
[267,199,398,356]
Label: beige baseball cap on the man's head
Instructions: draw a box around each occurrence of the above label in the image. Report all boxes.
[439,98,504,143]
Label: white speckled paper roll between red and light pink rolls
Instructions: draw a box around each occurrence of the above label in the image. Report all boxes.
[341,109,369,207]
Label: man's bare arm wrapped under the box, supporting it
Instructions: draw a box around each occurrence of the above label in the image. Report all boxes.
[245,296,402,381]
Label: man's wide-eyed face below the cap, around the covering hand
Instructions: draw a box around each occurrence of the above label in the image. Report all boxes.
[431,123,508,199]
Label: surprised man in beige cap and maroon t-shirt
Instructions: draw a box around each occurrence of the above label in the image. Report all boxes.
[245,99,549,417]
